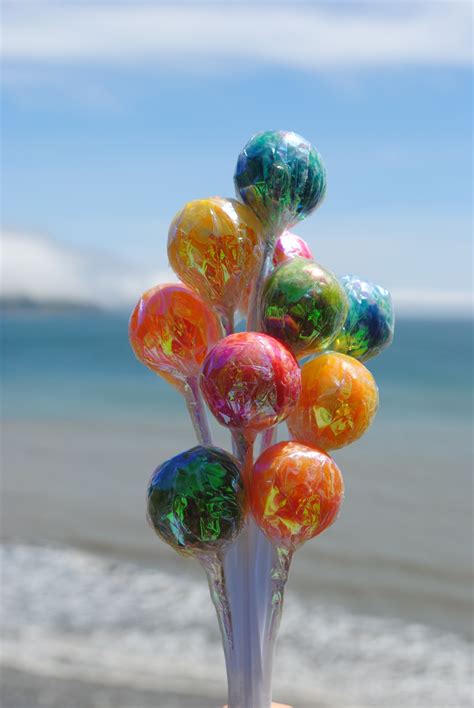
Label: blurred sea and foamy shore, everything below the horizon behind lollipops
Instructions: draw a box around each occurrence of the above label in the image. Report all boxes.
[1,312,474,708]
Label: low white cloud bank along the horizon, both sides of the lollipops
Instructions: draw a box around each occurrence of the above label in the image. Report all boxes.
[0,231,473,316]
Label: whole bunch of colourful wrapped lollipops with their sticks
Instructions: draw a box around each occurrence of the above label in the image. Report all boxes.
[129,131,393,708]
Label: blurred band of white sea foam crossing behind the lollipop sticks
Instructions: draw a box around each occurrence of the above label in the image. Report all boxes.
[1,544,472,708]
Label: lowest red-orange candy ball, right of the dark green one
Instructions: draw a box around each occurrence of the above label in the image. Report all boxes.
[249,442,344,549]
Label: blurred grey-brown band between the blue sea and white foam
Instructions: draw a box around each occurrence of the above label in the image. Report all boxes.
[2,416,473,639]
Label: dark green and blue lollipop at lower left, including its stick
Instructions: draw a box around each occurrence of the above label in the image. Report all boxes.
[147,446,246,696]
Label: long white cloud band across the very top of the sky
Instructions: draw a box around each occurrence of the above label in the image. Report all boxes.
[3,1,472,71]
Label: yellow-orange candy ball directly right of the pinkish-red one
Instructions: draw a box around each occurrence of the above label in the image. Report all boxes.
[287,352,378,450]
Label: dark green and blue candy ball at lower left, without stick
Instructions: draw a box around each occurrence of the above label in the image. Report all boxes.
[147,446,245,555]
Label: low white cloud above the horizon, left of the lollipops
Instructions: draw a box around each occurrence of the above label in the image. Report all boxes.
[0,231,176,308]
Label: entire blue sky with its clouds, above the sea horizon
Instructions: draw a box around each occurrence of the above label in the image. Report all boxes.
[1,0,472,315]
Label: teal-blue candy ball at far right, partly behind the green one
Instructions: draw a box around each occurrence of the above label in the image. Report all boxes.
[331,275,395,361]
